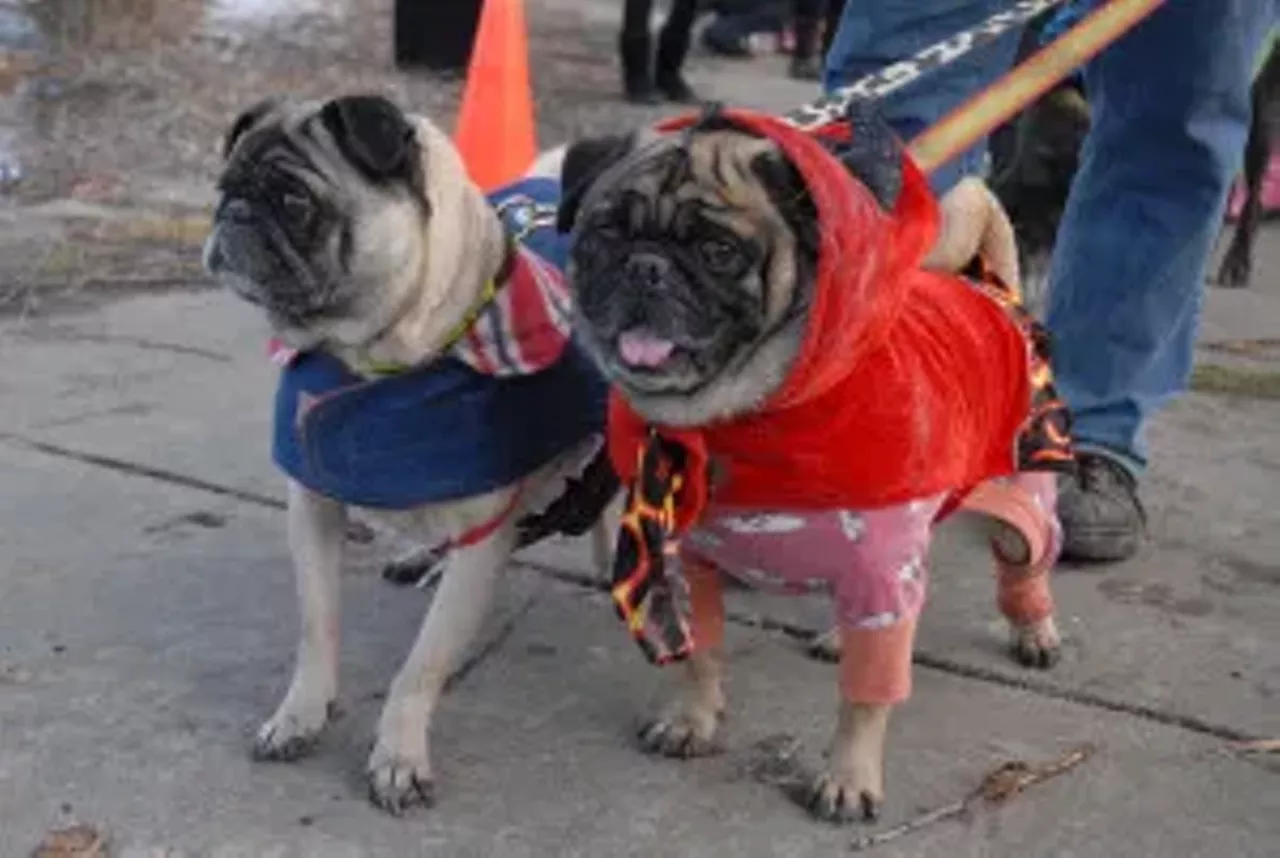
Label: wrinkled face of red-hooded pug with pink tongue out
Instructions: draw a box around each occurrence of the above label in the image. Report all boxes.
[561,127,817,425]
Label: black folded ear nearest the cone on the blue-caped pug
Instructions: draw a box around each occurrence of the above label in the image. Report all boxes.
[320,95,419,182]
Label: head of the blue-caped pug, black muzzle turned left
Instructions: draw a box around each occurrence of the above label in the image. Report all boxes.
[205,96,430,344]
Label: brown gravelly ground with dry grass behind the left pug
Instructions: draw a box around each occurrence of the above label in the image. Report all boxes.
[0,0,691,312]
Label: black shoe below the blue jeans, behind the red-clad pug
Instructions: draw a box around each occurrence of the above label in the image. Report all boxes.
[1057,452,1147,563]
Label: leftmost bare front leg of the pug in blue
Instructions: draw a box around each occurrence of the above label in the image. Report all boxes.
[253,480,347,761]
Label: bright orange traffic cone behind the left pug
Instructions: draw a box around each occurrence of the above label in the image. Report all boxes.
[453,0,538,191]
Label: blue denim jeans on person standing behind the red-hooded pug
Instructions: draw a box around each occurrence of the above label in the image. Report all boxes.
[827,0,1276,473]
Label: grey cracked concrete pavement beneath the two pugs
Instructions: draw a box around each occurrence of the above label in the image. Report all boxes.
[0,279,1280,857]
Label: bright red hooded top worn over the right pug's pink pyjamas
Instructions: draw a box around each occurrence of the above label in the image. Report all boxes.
[609,110,1032,531]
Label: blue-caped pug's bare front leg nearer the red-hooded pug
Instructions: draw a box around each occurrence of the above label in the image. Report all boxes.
[367,521,516,814]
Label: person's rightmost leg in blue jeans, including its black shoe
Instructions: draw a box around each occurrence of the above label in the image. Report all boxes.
[1047,0,1275,561]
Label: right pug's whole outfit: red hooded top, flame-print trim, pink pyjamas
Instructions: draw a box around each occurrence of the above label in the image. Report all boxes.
[599,104,1071,702]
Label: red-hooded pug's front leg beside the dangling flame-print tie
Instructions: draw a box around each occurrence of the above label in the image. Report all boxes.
[639,562,724,758]
